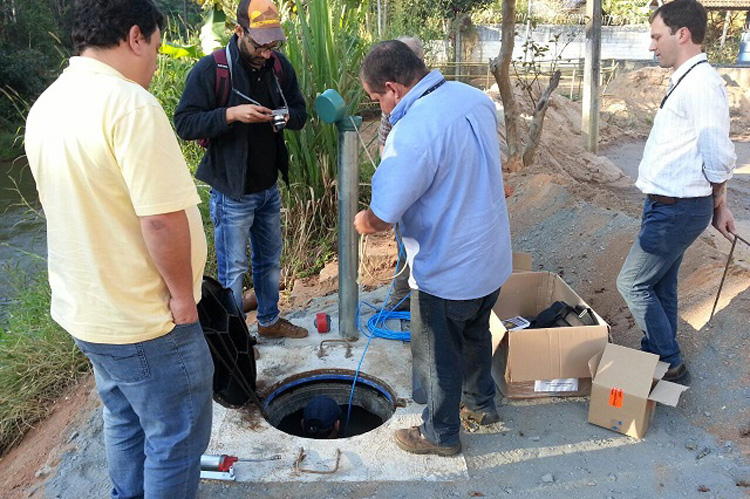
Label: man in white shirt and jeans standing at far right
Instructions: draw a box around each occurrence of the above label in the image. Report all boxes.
[617,0,736,381]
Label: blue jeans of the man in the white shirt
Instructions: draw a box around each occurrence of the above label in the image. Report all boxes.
[617,196,713,367]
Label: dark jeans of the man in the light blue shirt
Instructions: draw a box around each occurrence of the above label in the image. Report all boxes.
[411,289,500,446]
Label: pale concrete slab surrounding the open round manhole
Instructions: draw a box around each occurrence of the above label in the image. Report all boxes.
[200,289,468,482]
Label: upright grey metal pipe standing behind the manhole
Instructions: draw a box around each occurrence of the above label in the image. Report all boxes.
[336,116,362,340]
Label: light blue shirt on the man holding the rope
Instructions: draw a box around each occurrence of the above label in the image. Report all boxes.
[370,70,512,300]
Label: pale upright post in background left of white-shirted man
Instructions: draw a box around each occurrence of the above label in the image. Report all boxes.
[581,0,602,154]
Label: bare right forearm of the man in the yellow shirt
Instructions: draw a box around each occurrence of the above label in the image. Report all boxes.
[140,211,198,324]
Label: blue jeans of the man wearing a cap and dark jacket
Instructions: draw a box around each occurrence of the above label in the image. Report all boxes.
[211,185,281,326]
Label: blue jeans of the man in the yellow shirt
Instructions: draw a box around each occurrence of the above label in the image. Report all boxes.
[75,323,214,499]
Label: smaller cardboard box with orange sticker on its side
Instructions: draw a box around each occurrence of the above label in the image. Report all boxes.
[589,344,688,438]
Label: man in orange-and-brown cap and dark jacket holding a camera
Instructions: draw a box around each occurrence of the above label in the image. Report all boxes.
[174,0,308,338]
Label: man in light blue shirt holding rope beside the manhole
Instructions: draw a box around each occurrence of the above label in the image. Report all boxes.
[354,40,512,456]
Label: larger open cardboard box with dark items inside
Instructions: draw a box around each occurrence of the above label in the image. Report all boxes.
[490,272,609,398]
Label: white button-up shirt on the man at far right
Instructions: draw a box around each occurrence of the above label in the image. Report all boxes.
[635,54,737,198]
